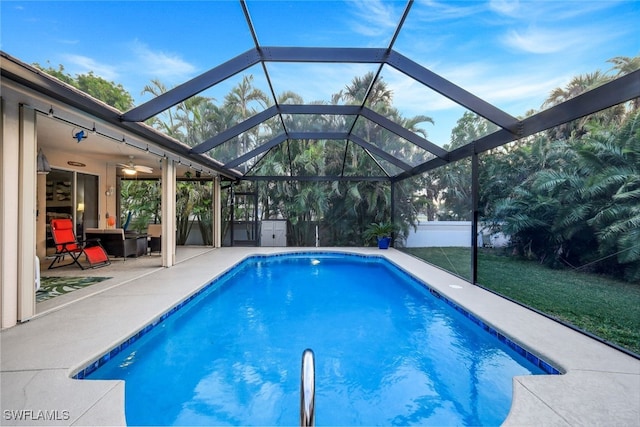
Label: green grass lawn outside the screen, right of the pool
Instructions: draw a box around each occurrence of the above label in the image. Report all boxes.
[402,248,640,354]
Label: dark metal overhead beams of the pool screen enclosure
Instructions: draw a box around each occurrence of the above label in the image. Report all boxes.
[121,0,640,183]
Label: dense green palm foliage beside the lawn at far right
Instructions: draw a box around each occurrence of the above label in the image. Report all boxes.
[495,112,640,281]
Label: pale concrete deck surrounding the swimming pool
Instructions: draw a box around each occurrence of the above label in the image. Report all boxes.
[0,248,640,426]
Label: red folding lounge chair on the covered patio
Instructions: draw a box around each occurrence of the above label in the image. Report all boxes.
[49,218,111,270]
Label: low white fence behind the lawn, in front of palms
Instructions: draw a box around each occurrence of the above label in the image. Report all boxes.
[406,221,509,248]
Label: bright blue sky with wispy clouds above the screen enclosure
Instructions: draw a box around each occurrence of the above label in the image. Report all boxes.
[0,0,640,144]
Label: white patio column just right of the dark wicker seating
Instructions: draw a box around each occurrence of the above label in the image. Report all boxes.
[161,158,176,267]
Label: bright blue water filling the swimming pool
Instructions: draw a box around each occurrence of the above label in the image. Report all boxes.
[87,254,544,425]
